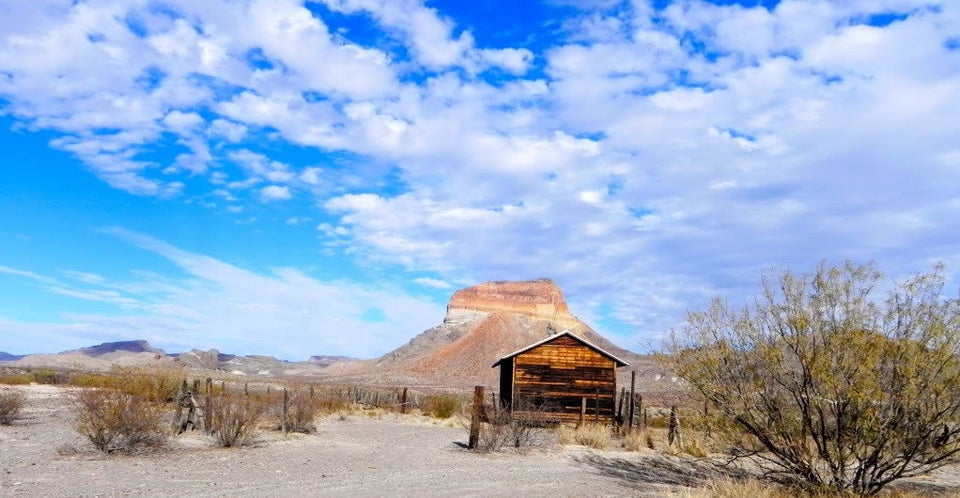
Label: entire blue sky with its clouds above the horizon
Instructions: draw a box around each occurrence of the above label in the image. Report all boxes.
[0,0,960,359]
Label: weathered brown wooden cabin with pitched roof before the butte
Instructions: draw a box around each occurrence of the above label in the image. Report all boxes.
[493,331,627,423]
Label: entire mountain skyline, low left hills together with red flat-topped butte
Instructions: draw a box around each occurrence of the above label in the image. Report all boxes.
[0,279,679,399]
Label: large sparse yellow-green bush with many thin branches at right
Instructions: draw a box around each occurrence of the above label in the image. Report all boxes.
[670,262,960,495]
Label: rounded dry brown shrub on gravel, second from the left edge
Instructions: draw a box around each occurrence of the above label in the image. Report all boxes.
[73,389,163,453]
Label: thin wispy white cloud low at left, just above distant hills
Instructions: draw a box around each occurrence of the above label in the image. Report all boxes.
[0,230,443,360]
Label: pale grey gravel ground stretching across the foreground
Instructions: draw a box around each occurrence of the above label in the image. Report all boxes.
[0,385,960,497]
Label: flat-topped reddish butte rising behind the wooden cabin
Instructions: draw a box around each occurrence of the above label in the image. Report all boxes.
[325,279,676,400]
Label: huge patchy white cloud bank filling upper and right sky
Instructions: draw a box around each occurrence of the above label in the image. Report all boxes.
[0,0,960,352]
